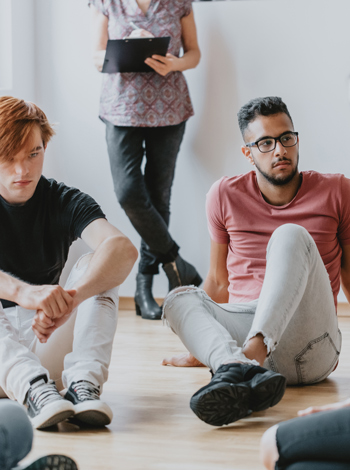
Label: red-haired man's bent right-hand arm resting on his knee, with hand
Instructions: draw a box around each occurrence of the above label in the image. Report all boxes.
[33,219,138,342]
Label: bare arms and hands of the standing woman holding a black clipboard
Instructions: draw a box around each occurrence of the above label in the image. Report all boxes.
[90,5,200,76]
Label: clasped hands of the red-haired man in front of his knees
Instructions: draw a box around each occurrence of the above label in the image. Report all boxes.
[18,285,78,343]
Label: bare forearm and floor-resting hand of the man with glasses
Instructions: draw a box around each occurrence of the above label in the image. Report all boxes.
[162,240,229,367]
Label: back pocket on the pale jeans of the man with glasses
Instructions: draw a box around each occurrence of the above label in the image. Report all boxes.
[294,333,340,385]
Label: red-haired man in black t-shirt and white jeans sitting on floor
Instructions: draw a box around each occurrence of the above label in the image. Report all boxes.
[0,96,137,428]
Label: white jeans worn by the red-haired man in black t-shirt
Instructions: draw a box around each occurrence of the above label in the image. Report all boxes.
[0,255,119,403]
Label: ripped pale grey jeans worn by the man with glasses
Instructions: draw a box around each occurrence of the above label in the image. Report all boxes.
[163,224,341,385]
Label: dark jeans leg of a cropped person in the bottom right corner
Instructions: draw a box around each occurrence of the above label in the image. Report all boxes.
[275,407,350,470]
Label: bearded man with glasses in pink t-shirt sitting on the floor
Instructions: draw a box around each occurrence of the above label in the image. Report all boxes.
[163,97,350,426]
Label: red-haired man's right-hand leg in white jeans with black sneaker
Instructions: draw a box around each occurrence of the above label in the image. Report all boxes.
[34,254,119,426]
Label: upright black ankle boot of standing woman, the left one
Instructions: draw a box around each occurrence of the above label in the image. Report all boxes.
[134,273,162,320]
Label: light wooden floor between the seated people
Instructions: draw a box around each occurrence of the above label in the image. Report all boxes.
[24,311,350,470]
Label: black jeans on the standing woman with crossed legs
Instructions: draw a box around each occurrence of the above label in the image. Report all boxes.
[105,121,186,274]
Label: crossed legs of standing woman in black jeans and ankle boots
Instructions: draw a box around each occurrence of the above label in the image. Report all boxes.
[105,121,201,319]
